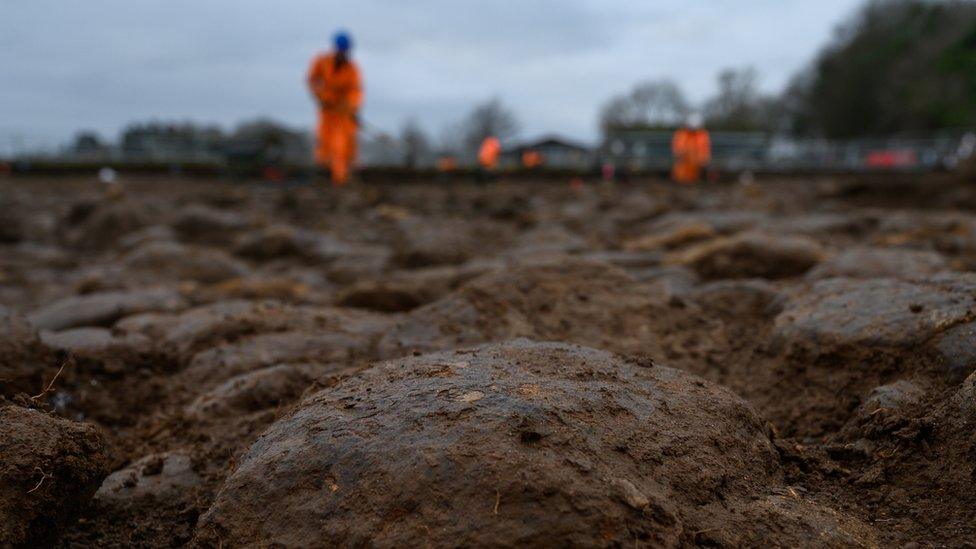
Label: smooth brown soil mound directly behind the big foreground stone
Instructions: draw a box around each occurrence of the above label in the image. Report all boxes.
[380,261,676,357]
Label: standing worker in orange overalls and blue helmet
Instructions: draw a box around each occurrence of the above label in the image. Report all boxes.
[308,31,363,186]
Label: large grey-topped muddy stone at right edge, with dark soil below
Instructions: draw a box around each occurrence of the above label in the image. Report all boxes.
[753,275,976,435]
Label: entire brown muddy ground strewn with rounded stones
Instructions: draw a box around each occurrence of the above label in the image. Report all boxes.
[0,176,976,547]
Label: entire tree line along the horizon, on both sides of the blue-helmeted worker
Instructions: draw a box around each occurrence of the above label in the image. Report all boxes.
[68,0,976,165]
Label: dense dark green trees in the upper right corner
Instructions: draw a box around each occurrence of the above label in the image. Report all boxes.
[783,0,976,137]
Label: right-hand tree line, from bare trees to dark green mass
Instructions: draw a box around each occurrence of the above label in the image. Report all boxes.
[600,0,976,138]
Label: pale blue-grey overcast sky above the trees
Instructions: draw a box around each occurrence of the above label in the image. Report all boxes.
[0,0,860,149]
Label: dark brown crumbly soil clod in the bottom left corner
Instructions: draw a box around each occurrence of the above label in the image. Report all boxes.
[0,402,108,546]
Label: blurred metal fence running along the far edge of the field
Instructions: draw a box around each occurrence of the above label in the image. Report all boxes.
[4,129,976,172]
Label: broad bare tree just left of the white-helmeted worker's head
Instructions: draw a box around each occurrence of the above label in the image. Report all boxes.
[600,80,691,131]
